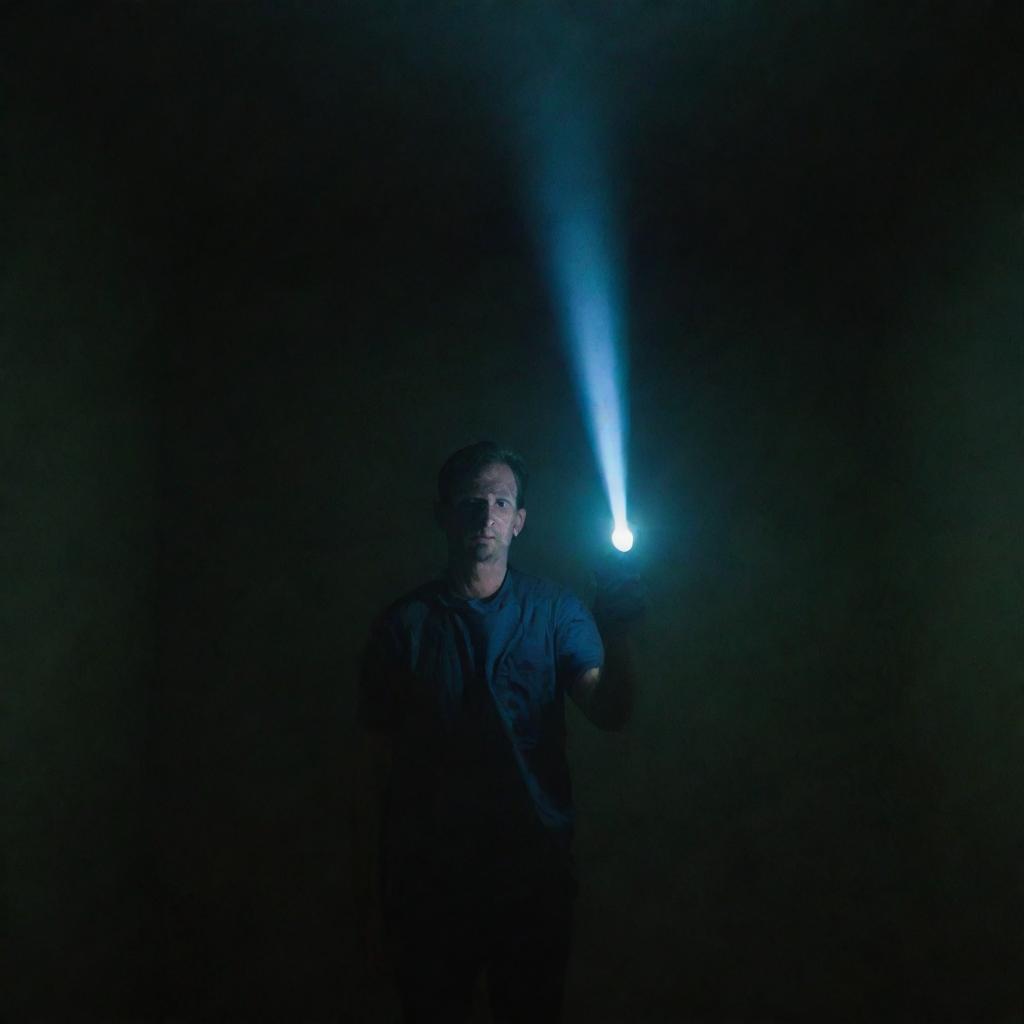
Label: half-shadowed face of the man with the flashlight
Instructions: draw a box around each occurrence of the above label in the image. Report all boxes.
[441,463,526,562]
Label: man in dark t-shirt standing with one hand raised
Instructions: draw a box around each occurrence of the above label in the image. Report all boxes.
[356,441,639,1022]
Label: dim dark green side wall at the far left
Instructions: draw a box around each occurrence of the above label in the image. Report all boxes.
[0,54,159,1020]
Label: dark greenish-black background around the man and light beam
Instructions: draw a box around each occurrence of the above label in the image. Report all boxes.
[0,0,1024,1024]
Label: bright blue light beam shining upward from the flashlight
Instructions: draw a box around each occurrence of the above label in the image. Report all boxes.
[535,77,633,551]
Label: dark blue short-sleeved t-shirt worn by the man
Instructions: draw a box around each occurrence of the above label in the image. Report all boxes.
[358,567,604,901]
